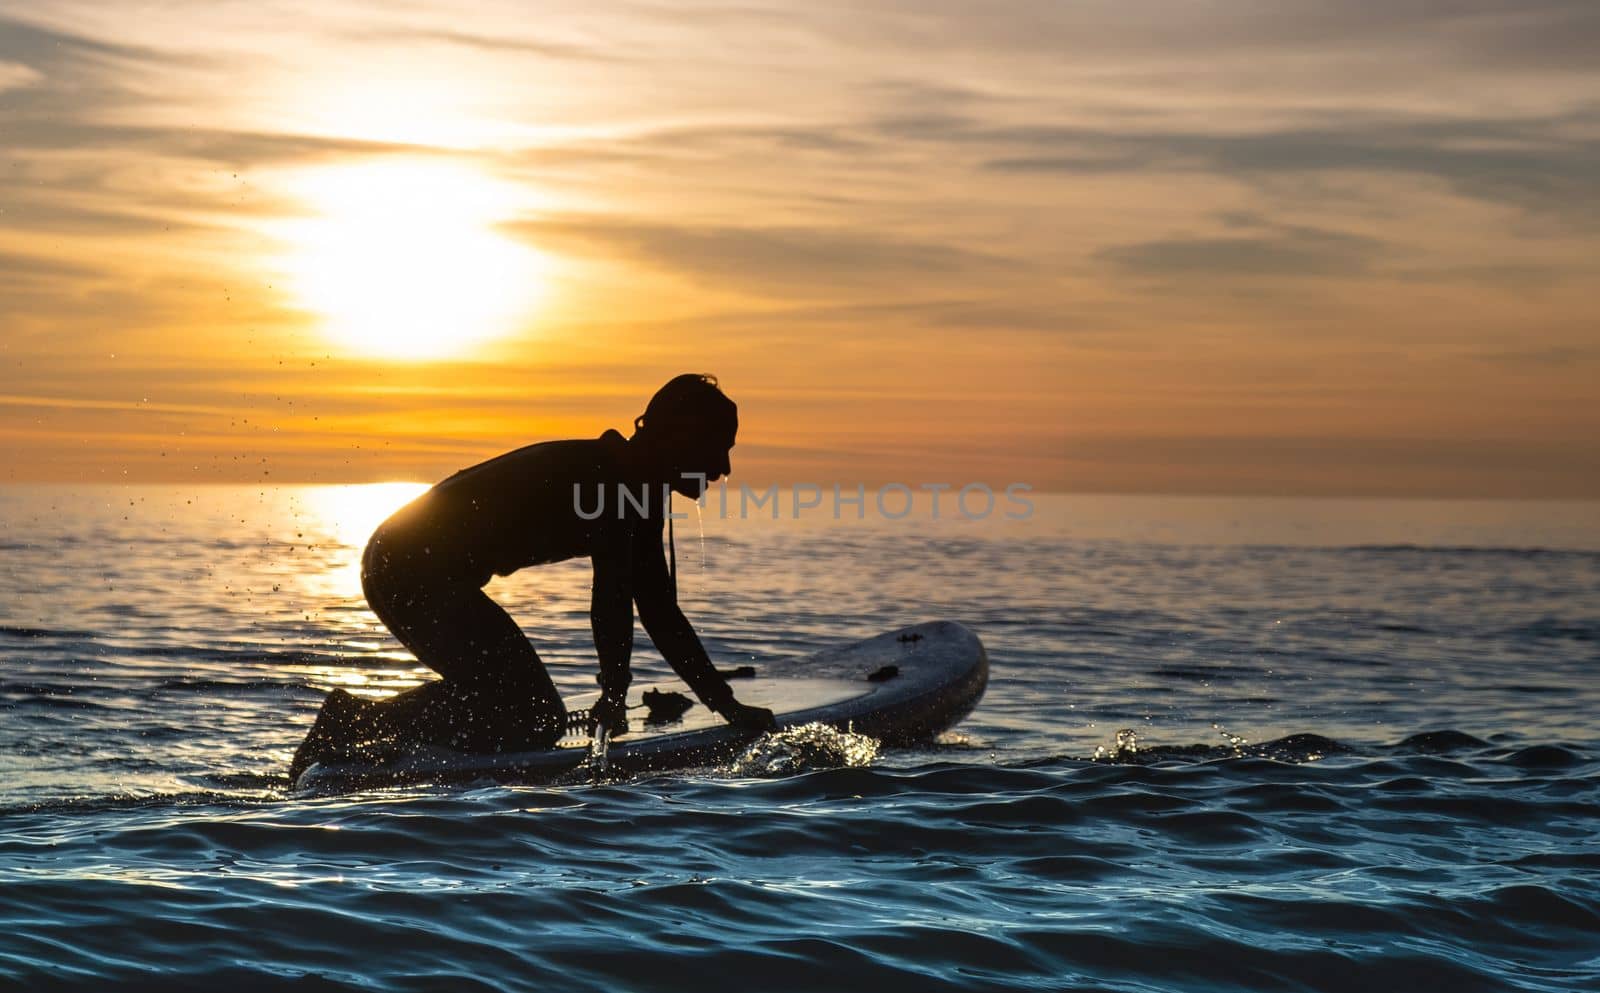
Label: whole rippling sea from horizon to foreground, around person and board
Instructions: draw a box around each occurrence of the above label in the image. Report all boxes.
[0,486,1600,993]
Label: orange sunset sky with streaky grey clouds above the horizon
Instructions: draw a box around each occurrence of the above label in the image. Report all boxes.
[0,0,1600,499]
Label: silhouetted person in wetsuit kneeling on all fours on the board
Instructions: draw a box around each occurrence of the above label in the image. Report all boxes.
[299,374,774,779]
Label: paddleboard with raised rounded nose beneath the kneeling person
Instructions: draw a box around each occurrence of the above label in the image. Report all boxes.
[294,620,989,793]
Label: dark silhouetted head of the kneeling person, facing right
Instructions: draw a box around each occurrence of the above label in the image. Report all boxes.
[634,373,739,499]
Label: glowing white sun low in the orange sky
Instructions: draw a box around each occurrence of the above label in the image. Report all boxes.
[283,162,547,360]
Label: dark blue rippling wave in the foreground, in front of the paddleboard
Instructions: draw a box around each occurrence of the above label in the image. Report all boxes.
[0,731,1600,993]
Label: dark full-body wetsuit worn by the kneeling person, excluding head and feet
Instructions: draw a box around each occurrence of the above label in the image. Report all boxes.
[362,430,733,752]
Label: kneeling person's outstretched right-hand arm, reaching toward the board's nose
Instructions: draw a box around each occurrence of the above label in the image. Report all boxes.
[634,511,774,728]
